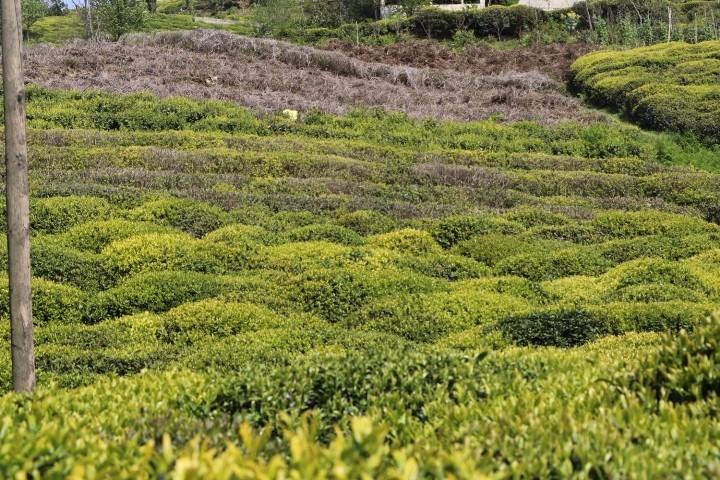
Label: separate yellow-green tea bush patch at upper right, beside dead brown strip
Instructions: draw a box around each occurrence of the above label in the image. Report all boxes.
[570,41,720,142]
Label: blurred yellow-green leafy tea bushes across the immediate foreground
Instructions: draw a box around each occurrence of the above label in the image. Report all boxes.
[0,328,720,478]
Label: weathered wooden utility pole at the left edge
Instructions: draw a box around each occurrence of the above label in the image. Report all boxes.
[0,0,35,392]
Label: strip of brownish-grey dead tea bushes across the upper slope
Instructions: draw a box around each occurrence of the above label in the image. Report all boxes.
[26,30,598,123]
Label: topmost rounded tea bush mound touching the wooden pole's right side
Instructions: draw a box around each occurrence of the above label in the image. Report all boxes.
[30,196,112,234]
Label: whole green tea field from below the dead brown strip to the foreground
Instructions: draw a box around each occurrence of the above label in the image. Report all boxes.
[0,82,720,479]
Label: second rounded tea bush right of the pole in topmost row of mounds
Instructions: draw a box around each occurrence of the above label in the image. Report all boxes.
[125,198,230,237]
